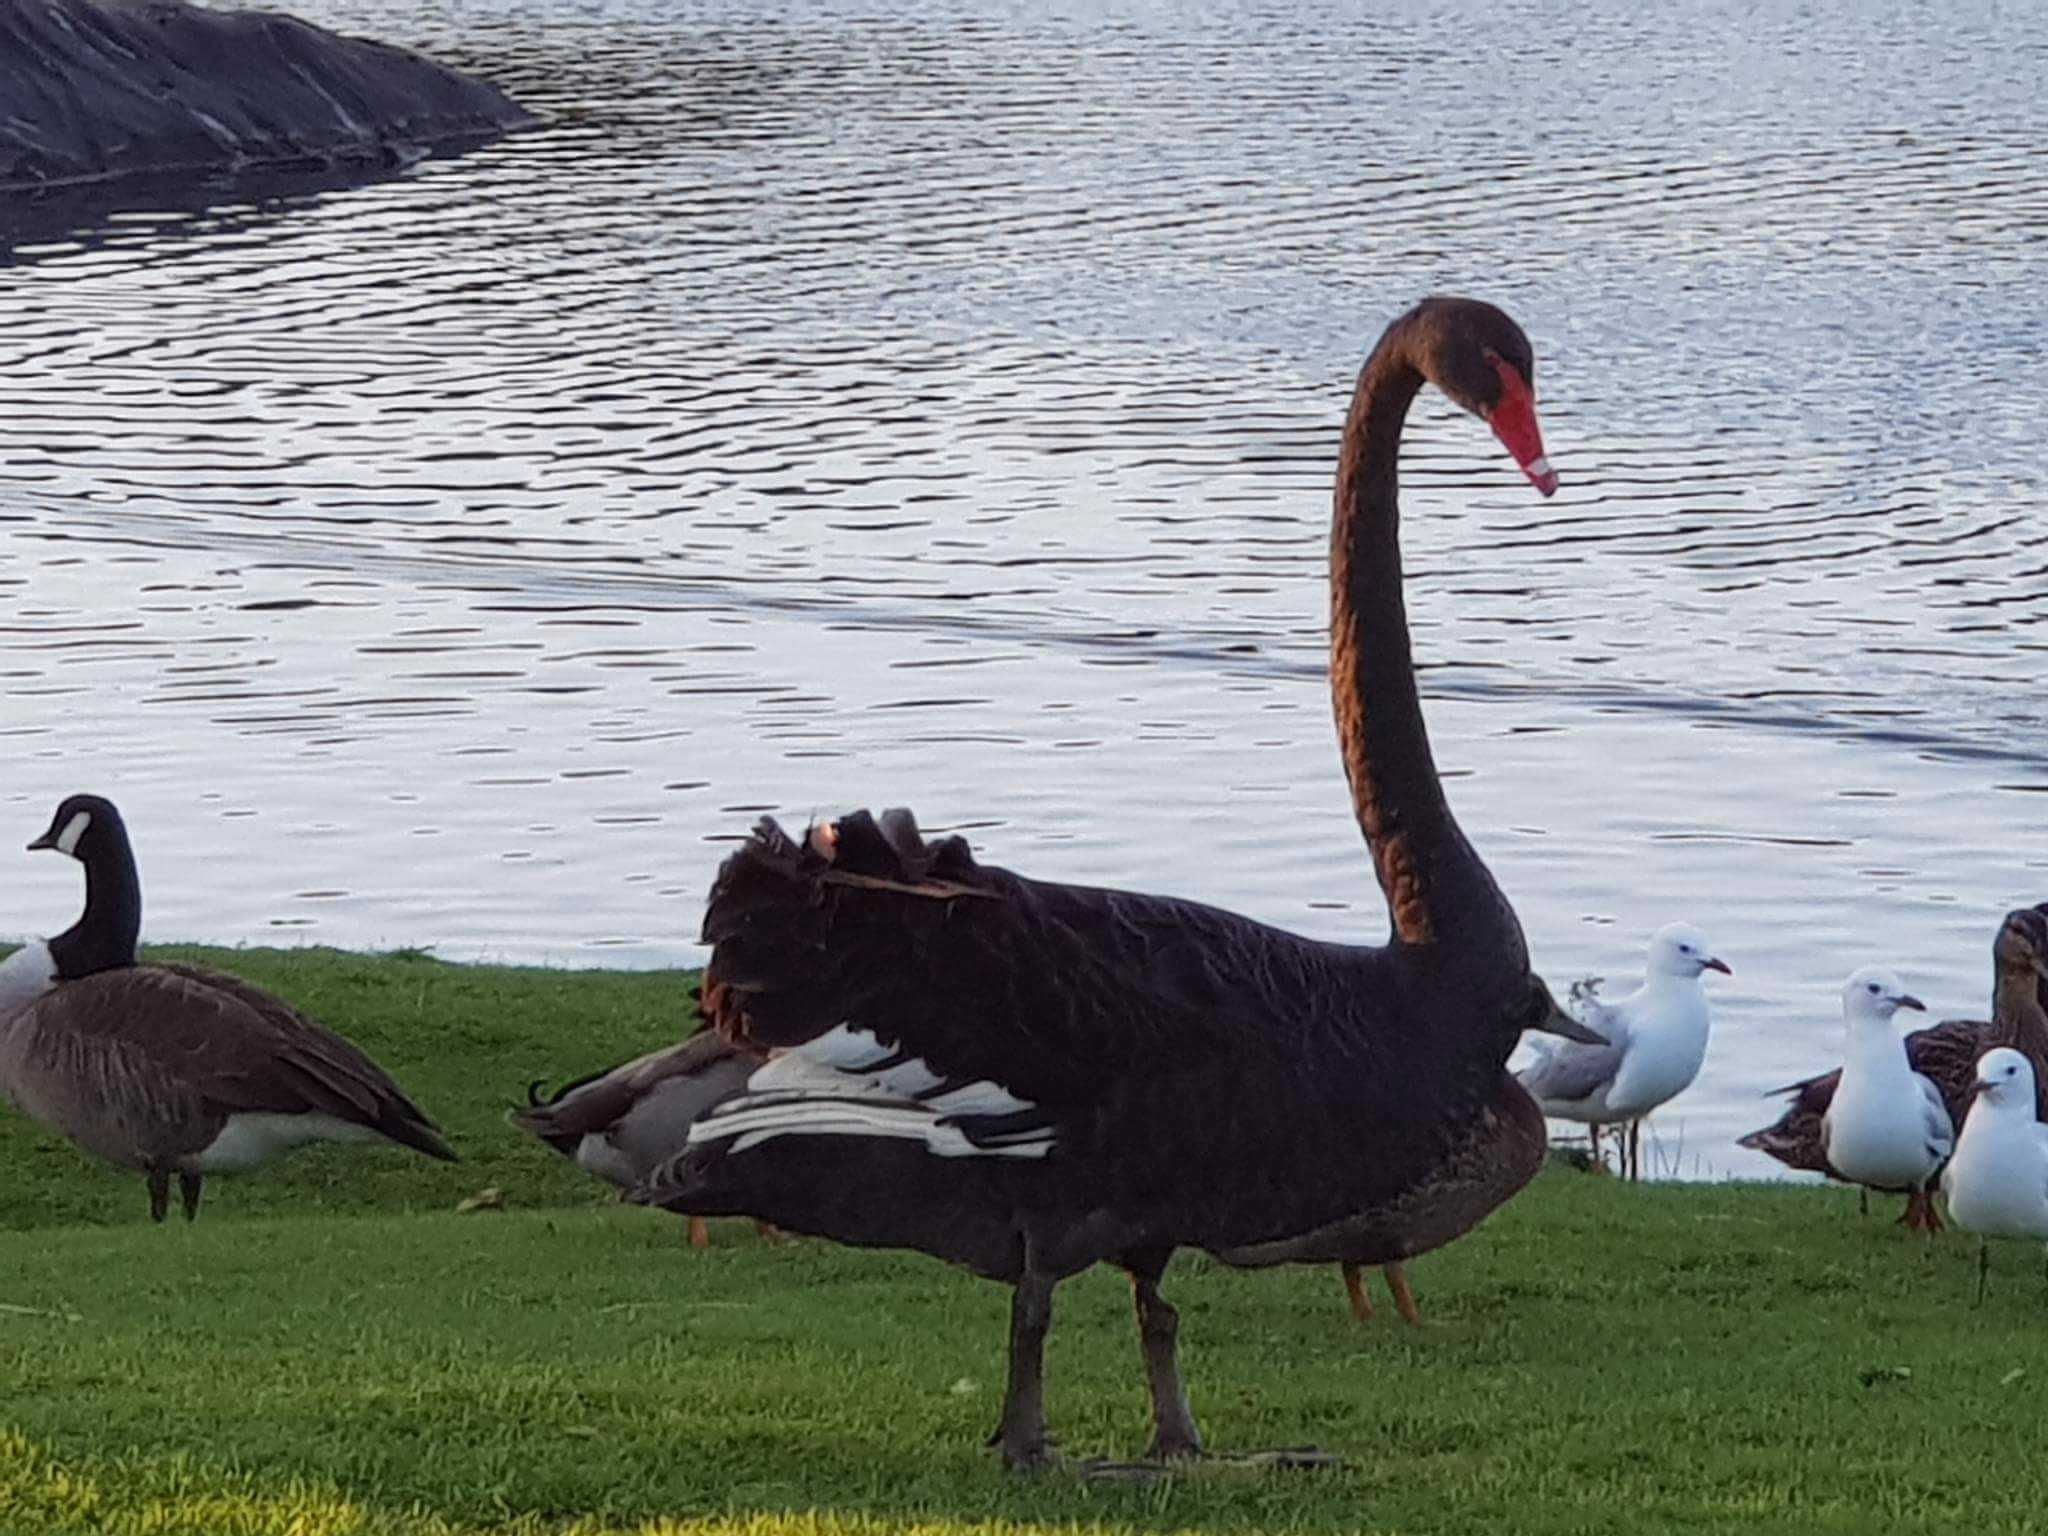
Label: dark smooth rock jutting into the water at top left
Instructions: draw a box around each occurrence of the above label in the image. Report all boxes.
[0,0,532,188]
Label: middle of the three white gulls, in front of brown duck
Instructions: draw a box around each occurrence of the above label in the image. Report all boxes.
[1821,967,1956,1235]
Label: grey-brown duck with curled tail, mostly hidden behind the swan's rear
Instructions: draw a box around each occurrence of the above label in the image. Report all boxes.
[512,1030,776,1247]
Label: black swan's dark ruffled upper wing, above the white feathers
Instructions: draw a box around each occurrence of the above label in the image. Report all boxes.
[702,811,1358,1110]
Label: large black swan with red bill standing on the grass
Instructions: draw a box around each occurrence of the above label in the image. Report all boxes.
[637,297,1585,1468]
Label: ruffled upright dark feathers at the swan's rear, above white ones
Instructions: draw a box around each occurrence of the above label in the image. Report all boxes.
[700,811,1001,1047]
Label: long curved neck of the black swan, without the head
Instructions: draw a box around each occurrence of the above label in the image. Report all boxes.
[1329,324,1528,975]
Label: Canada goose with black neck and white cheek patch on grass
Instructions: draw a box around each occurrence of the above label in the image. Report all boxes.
[0,795,455,1221]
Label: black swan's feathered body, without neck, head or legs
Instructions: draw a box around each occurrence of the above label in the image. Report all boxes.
[641,811,1548,1278]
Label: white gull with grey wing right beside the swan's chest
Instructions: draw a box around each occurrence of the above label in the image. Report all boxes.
[1518,924,1733,1178]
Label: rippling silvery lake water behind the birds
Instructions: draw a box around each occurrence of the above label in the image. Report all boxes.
[0,0,2048,1176]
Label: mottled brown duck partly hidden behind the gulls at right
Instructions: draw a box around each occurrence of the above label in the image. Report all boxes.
[1737,901,2048,1227]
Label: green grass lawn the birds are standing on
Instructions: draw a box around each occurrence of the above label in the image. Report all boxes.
[0,952,2048,1536]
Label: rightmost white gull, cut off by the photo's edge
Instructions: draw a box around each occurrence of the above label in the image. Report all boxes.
[1942,1044,2048,1303]
